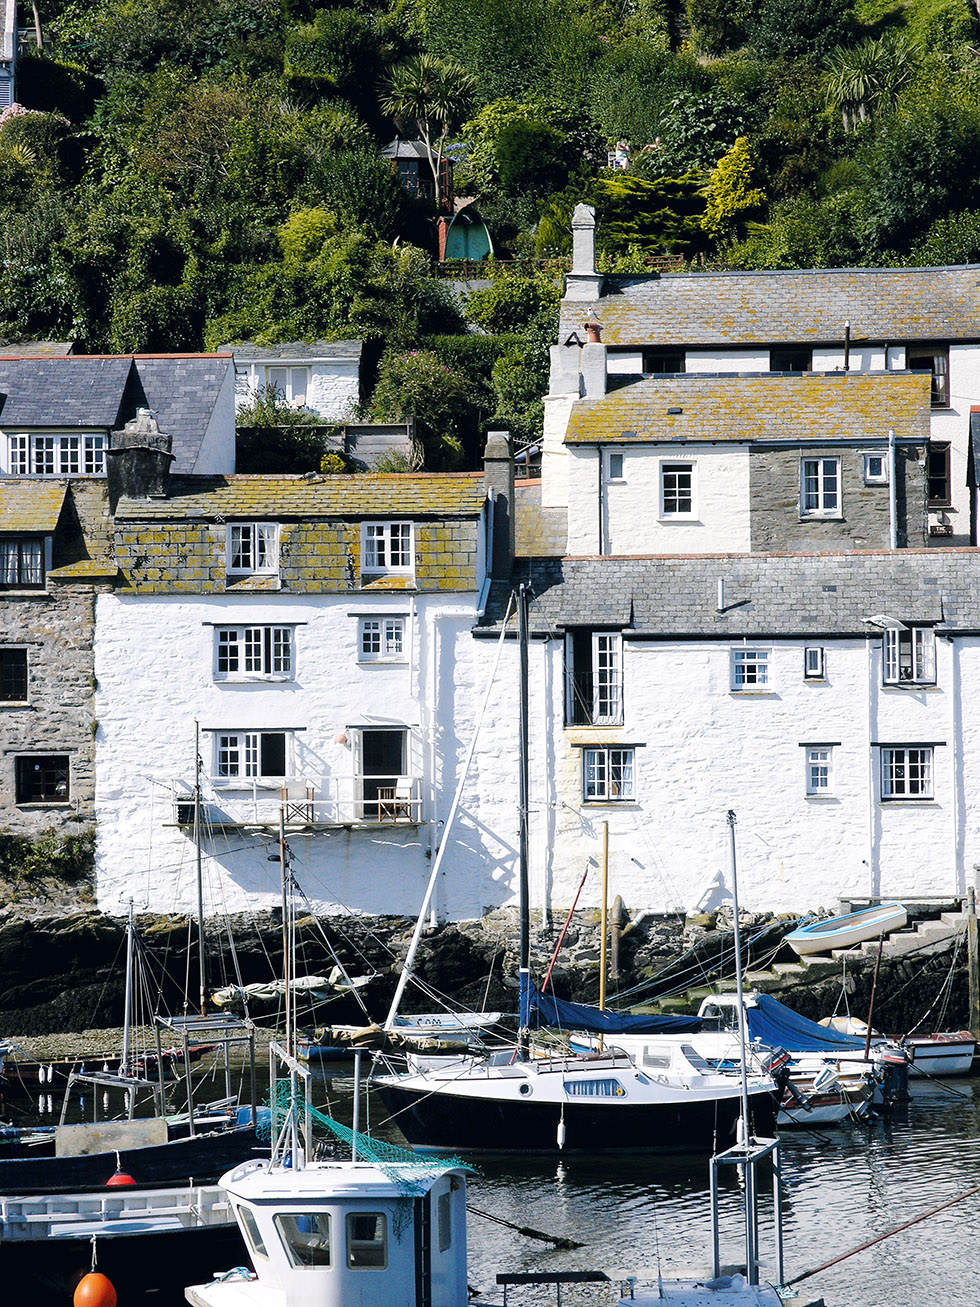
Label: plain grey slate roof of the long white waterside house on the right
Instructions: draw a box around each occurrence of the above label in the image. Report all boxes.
[485,549,980,639]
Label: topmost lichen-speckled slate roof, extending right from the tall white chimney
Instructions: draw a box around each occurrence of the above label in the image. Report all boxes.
[558,264,980,346]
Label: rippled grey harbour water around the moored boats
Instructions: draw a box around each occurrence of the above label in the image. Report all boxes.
[11,1073,980,1307]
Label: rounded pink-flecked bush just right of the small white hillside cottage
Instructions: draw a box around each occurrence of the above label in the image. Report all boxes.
[370,349,473,472]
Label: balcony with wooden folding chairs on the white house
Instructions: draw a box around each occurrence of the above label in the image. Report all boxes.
[170,776,422,831]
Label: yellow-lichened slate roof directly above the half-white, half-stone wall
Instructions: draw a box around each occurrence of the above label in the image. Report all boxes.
[564,372,932,444]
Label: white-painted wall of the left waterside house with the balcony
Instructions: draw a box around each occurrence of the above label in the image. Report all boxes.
[95,593,497,918]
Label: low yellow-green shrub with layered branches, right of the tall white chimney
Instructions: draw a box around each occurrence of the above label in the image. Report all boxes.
[597,173,706,254]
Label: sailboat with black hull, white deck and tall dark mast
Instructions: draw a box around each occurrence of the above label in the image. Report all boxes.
[374,586,776,1153]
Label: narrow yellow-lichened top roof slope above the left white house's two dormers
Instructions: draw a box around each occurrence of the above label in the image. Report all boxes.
[116,473,486,521]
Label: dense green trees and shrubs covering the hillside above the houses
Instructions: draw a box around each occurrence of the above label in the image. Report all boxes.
[0,0,980,467]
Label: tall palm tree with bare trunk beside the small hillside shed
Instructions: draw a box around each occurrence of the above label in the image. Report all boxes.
[382,55,476,210]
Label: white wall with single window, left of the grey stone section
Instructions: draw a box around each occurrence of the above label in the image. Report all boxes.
[566,444,751,554]
